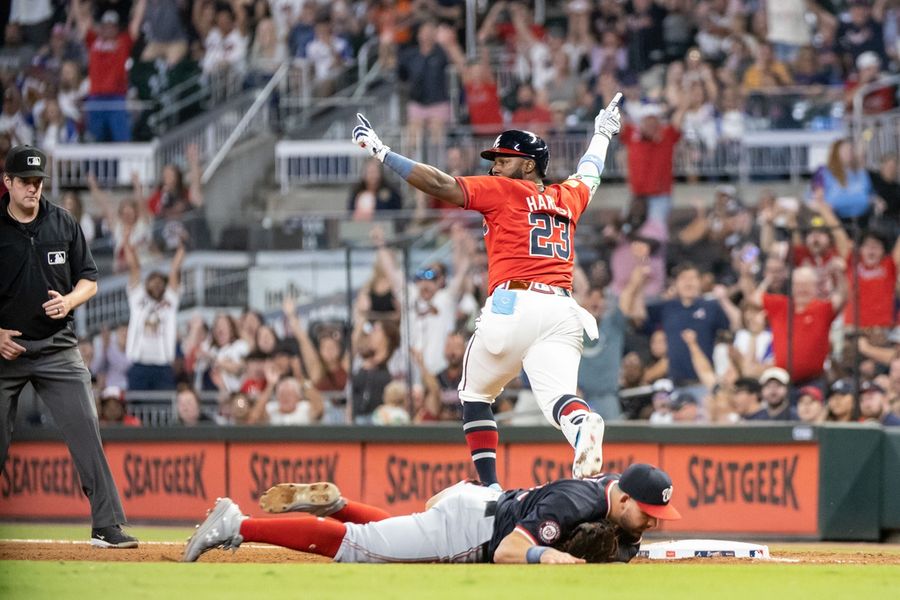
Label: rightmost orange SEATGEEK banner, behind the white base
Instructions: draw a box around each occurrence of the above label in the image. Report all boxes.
[659,443,819,536]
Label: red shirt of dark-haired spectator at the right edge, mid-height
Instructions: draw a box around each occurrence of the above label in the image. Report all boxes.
[844,256,897,327]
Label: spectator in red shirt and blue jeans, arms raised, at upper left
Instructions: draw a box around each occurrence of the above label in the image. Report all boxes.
[72,0,143,142]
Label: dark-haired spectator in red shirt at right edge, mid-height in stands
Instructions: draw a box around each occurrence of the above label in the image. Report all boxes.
[844,231,900,329]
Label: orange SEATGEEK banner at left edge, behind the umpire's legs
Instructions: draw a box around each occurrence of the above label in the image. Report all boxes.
[0,442,90,518]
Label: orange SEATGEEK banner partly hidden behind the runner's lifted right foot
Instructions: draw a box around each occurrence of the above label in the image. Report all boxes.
[500,439,659,488]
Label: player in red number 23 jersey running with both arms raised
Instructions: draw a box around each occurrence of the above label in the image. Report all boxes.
[353,94,621,487]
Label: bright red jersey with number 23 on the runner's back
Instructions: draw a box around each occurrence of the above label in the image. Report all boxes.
[456,175,590,292]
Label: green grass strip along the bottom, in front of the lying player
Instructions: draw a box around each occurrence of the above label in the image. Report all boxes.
[0,561,900,600]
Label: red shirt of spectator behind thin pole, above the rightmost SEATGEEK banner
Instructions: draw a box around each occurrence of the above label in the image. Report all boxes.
[763,294,835,383]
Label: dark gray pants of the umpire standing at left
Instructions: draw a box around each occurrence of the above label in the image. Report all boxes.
[0,334,125,527]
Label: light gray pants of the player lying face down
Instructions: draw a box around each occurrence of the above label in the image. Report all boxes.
[334,483,500,563]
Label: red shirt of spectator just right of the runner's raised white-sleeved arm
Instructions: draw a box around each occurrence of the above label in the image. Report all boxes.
[619,123,681,196]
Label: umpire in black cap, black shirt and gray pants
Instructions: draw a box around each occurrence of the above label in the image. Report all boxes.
[0,146,138,548]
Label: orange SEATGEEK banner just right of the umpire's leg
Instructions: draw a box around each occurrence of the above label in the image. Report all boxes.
[104,442,227,520]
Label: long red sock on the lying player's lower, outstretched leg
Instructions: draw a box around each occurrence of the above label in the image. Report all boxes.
[241,517,347,558]
